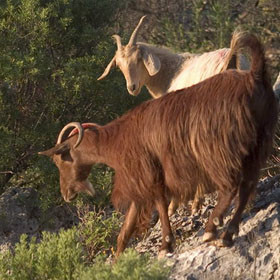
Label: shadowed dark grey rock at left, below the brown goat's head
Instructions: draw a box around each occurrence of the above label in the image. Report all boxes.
[0,186,78,251]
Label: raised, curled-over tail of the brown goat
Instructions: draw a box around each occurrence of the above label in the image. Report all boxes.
[223,31,267,81]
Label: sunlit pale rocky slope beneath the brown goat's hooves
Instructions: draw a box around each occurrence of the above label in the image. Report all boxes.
[136,176,280,280]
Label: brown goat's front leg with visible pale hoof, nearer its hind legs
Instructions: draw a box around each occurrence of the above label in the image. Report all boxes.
[155,197,174,258]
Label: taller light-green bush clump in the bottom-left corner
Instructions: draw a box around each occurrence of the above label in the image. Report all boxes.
[0,228,84,280]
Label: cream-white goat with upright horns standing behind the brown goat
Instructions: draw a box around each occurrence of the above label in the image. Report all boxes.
[98,16,249,215]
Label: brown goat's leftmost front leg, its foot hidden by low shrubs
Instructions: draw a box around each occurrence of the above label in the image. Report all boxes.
[116,202,138,258]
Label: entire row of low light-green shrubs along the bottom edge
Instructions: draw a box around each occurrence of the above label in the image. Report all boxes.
[0,233,170,280]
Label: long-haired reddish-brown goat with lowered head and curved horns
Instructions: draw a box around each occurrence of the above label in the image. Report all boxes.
[40,33,278,256]
